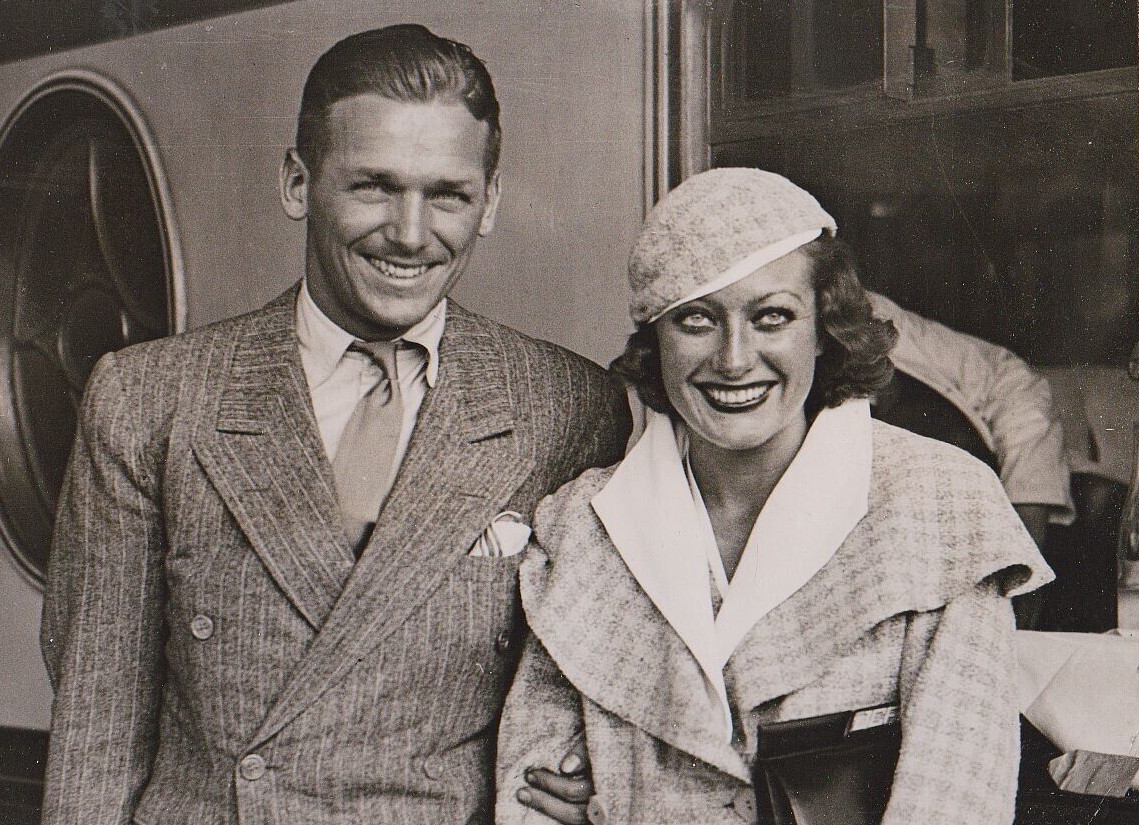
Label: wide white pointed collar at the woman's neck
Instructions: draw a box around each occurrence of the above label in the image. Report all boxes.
[591,399,871,738]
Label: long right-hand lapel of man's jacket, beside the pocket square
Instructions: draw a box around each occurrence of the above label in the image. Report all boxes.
[251,303,533,746]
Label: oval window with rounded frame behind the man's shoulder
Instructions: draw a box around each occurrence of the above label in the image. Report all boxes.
[0,80,173,579]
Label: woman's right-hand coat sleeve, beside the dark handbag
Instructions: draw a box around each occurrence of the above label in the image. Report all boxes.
[883,579,1019,825]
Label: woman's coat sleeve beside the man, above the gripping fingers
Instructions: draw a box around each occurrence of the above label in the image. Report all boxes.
[494,635,584,825]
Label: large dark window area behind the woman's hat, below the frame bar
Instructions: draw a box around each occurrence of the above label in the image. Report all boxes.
[712,91,1139,366]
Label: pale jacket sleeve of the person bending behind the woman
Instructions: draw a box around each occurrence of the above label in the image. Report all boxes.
[868,292,1075,524]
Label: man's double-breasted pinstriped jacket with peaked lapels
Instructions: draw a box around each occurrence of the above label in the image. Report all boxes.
[42,289,628,825]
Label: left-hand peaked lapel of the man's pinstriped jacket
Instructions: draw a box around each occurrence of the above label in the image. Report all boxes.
[194,288,353,629]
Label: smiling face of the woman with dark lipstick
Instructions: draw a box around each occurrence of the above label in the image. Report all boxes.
[655,251,822,459]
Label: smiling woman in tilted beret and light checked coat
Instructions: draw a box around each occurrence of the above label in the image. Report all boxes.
[498,169,1051,825]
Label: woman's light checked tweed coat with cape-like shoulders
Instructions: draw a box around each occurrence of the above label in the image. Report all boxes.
[497,422,1051,825]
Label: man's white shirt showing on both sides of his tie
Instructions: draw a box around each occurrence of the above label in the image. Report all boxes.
[296,284,446,467]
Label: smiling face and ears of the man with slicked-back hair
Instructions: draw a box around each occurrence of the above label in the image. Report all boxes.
[281,93,499,341]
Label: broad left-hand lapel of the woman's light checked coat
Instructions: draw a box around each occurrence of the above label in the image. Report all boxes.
[521,477,748,782]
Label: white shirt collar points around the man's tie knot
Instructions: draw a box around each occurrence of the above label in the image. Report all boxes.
[296,281,446,386]
